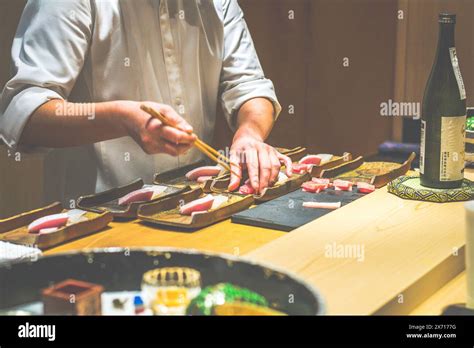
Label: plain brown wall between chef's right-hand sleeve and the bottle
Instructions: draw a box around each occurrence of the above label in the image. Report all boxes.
[216,0,397,154]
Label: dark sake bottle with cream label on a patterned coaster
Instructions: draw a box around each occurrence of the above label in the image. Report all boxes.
[420,13,466,188]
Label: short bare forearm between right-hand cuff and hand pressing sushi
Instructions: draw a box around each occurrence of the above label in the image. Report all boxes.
[234,98,275,141]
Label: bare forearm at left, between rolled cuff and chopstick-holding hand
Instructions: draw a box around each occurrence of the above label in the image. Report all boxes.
[20,100,127,148]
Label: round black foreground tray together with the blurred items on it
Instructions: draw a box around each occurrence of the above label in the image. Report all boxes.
[0,248,325,316]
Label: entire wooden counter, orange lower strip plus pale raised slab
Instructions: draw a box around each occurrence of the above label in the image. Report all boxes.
[46,171,474,314]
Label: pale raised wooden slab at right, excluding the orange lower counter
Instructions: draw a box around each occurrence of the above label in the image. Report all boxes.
[247,171,473,314]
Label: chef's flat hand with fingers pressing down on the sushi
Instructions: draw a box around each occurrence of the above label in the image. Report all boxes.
[229,134,292,193]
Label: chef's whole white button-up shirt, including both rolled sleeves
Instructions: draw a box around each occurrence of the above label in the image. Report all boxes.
[0,0,281,202]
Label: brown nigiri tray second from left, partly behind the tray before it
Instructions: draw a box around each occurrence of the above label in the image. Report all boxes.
[77,179,190,219]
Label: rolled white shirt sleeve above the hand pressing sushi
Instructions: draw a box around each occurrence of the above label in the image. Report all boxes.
[220,0,281,129]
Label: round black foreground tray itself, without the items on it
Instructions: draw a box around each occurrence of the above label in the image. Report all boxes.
[0,248,325,315]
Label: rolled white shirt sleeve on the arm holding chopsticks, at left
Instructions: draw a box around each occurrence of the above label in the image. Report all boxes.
[0,0,92,148]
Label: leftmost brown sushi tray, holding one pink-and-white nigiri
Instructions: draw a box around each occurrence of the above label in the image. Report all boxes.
[0,203,113,250]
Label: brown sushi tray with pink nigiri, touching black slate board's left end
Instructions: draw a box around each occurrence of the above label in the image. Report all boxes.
[138,188,254,229]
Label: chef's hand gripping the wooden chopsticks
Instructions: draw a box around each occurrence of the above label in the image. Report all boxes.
[116,101,196,156]
